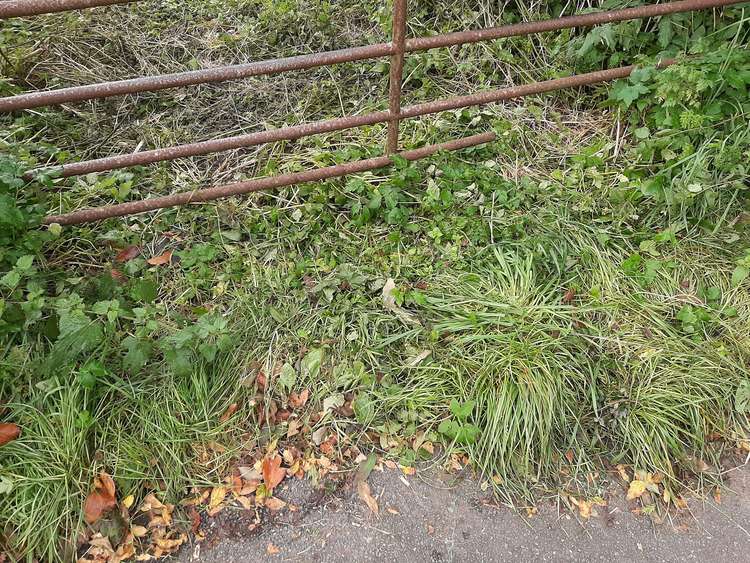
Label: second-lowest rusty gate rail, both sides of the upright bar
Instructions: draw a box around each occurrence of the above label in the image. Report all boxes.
[27,60,674,178]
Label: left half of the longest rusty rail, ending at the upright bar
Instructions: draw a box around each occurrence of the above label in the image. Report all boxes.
[0,44,391,112]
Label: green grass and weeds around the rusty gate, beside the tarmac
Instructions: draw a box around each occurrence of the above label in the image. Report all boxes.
[0,0,750,560]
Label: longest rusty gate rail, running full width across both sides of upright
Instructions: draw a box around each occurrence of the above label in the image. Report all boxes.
[0,0,747,112]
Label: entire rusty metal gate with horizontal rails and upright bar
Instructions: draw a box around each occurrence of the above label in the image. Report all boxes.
[0,0,747,225]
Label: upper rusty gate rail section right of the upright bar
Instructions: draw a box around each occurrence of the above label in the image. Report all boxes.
[406,0,747,52]
